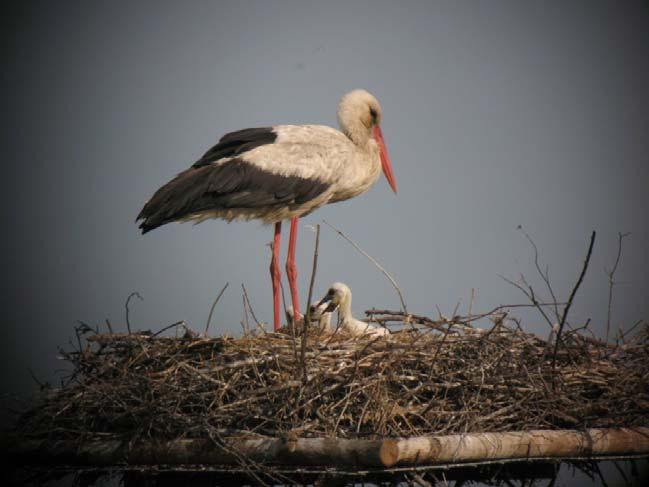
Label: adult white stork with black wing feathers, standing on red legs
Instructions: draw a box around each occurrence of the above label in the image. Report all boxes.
[137,90,397,330]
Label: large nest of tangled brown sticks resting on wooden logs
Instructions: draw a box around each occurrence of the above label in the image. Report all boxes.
[11,312,649,440]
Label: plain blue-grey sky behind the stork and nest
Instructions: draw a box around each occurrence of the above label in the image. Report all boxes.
[0,1,649,400]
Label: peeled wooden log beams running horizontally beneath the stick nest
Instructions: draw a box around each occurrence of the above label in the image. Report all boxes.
[2,427,649,469]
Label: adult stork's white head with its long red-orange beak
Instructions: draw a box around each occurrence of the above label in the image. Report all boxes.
[338,90,397,193]
